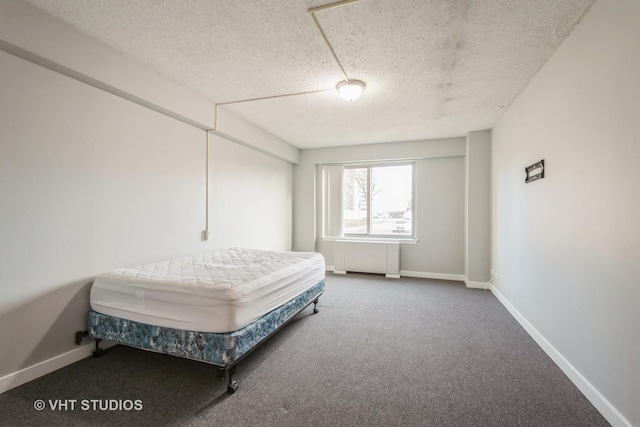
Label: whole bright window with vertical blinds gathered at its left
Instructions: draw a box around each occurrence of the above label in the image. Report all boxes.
[325,163,415,238]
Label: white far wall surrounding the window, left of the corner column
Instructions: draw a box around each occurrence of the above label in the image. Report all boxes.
[293,138,466,279]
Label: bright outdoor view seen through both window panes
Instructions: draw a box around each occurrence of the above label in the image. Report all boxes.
[342,164,413,237]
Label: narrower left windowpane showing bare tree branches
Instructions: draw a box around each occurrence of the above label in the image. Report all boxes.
[342,168,369,234]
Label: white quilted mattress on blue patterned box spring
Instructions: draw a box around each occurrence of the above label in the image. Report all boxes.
[90,248,325,333]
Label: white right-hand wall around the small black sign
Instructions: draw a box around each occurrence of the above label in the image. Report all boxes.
[492,0,640,425]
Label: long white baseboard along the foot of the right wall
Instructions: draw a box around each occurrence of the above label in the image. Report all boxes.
[490,286,632,427]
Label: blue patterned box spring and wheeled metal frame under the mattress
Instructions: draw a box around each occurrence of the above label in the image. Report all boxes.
[76,279,325,394]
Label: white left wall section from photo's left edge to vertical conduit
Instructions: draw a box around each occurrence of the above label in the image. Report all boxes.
[0,52,205,377]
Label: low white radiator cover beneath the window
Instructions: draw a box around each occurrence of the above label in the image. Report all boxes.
[333,241,400,279]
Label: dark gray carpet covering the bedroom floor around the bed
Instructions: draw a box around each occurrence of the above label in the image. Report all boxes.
[0,274,609,427]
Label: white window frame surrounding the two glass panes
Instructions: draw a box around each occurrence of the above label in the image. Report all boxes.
[338,160,418,241]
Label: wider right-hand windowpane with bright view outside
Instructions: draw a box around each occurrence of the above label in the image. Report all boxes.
[371,165,413,236]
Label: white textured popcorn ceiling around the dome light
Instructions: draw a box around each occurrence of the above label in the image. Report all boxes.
[27,0,594,148]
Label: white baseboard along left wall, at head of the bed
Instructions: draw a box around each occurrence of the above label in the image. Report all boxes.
[0,341,113,394]
